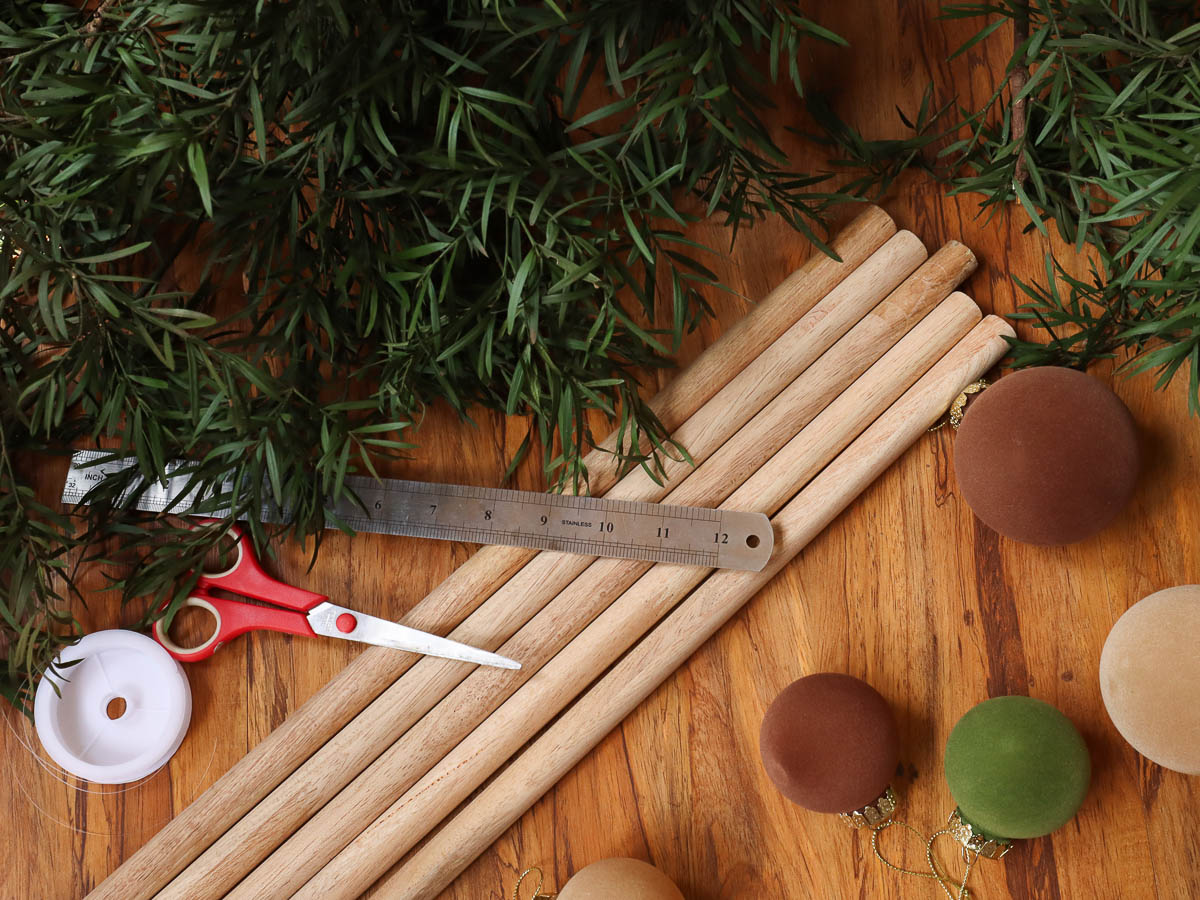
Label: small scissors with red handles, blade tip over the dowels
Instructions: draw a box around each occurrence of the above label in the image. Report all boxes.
[152,518,521,668]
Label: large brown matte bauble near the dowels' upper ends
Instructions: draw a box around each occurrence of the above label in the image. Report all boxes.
[954,366,1139,545]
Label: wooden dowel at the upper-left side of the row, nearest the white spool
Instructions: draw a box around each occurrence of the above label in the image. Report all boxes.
[90,206,896,900]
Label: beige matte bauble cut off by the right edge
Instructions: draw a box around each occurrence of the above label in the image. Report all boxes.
[1100,584,1200,775]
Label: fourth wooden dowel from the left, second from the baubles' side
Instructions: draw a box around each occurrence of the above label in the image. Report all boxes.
[295,294,979,898]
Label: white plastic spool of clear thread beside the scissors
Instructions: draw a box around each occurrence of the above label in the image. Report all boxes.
[34,629,192,785]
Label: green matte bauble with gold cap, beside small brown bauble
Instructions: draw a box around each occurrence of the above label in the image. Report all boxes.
[946,697,1092,840]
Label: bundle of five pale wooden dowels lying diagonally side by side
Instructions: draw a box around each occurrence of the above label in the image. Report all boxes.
[91,208,1012,900]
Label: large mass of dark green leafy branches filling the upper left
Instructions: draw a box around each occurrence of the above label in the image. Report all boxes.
[0,0,864,710]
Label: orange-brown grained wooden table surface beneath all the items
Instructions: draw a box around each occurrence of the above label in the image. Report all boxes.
[0,0,1200,900]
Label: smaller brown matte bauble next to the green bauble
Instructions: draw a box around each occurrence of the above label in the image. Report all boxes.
[758,672,900,812]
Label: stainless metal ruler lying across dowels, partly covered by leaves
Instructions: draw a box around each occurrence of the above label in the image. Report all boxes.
[62,450,774,571]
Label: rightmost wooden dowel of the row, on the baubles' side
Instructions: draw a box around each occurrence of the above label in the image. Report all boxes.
[369,317,1013,900]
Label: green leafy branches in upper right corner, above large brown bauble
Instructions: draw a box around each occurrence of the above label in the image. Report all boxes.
[946,0,1200,413]
